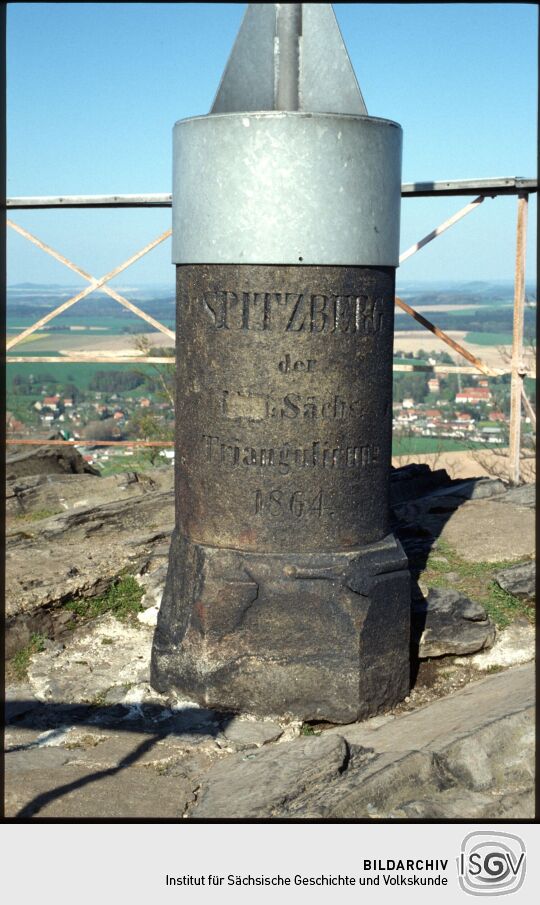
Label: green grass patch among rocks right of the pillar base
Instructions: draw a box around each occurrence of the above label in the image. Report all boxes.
[419,540,535,629]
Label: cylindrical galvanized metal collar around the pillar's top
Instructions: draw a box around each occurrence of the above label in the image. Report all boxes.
[173,111,401,267]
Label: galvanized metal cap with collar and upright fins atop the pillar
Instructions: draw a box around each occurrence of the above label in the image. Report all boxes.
[173,3,401,267]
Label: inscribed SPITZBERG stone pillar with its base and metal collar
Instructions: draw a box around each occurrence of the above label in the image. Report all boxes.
[152,4,410,722]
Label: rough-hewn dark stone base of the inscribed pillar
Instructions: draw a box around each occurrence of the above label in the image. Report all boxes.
[151,531,410,723]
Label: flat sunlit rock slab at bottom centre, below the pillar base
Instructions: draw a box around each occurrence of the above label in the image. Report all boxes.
[191,736,347,820]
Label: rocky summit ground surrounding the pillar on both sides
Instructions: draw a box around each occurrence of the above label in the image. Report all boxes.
[6,456,534,820]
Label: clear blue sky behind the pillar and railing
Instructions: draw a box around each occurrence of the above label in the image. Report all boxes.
[7,3,538,287]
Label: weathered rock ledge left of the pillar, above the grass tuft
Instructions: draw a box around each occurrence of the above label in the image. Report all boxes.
[6,490,174,656]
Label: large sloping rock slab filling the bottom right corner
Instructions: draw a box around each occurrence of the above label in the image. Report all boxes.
[298,666,534,819]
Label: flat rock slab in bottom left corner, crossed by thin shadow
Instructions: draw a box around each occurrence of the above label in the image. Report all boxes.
[5,704,223,820]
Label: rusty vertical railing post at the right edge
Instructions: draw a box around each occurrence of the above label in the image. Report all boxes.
[508,192,529,484]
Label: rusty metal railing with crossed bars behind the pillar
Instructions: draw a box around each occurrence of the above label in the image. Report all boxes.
[6,177,538,483]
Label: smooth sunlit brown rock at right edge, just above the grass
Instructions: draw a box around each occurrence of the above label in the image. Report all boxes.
[441,494,536,562]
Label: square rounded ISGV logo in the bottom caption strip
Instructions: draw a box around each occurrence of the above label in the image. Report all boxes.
[457,832,526,896]
